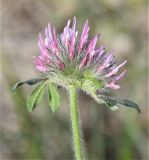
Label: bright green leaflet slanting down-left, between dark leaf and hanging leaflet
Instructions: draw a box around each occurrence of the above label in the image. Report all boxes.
[27,81,47,112]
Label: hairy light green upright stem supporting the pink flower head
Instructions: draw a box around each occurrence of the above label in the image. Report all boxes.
[69,85,83,160]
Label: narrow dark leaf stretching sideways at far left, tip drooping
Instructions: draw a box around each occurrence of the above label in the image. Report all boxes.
[12,78,47,92]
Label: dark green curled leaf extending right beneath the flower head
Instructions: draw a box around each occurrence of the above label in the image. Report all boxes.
[98,95,141,113]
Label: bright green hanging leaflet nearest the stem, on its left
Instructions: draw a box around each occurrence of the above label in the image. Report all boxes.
[48,83,60,112]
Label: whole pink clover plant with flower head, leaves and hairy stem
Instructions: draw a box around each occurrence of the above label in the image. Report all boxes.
[13,17,140,160]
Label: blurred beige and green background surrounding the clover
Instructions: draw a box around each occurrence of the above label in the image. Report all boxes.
[0,0,149,160]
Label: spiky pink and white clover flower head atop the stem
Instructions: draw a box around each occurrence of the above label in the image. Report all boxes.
[34,17,127,89]
